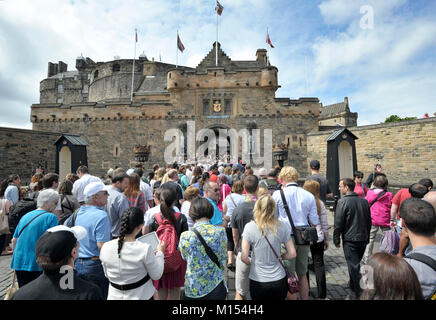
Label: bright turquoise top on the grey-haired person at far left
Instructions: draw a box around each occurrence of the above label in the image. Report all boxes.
[11,210,58,271]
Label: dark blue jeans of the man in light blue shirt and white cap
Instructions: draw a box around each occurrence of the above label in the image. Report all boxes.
[74,258,109,300]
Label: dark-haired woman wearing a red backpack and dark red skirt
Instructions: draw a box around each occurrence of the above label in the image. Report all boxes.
[149,189,188,300]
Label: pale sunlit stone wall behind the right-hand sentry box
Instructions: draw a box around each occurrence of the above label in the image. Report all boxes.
[307,118,436,185]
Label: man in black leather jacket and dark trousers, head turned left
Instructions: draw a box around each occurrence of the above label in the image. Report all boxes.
[334,178,371,300]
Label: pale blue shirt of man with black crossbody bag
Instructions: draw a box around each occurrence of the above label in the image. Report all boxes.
[272,183,319,235]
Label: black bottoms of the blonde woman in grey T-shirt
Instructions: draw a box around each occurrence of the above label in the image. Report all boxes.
[250,277,288,301]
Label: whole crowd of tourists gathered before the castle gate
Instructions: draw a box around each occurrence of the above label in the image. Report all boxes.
[0,160,436,300]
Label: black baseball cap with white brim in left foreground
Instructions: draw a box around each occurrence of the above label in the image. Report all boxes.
[35,225,87,263]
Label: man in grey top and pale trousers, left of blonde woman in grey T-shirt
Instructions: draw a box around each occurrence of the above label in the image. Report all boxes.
[231,175,259,300]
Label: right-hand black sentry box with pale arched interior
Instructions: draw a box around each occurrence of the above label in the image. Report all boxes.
[326,128,358,197]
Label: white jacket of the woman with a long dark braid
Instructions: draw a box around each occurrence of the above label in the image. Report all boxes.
[100,239,164,300]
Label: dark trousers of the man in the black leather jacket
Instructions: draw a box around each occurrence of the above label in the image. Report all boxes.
[342,241,366,297]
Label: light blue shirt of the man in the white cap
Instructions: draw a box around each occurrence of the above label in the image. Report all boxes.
[67,206,111,258]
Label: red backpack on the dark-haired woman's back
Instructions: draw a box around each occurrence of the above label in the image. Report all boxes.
[154,212,182,273]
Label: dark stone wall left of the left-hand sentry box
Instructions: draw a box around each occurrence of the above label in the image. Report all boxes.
[0,128,60,185]
